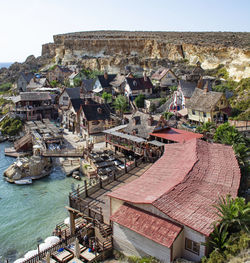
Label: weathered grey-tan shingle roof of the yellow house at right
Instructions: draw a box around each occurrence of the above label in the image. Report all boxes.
[186,88,223,112]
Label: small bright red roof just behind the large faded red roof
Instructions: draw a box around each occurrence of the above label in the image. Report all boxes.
[150,128,203,142]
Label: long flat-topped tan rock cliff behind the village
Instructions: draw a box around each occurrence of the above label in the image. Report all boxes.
[42,31,250,80]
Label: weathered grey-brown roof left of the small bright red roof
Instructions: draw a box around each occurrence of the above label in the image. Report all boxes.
[124,111,158,139]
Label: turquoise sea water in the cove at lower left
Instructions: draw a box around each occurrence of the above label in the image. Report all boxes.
[0,143,82,263]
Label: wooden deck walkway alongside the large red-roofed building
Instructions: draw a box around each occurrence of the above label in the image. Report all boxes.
[85,163,152,224]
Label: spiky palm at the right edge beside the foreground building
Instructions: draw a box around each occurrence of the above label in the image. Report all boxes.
[214,195,250,233]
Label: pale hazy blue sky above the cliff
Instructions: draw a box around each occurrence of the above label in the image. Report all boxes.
[0,0,250,62]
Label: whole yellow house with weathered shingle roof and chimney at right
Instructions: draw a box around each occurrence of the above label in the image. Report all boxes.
[186,88,229,122]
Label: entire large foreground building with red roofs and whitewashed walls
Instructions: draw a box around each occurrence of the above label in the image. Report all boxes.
[108,139,241,263]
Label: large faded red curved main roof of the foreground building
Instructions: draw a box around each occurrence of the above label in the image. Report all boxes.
[109,139,241,236]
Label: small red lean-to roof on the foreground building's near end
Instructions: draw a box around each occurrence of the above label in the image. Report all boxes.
[111,204,182,248]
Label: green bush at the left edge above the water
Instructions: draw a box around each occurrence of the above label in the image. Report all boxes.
[0,117,23,136]
